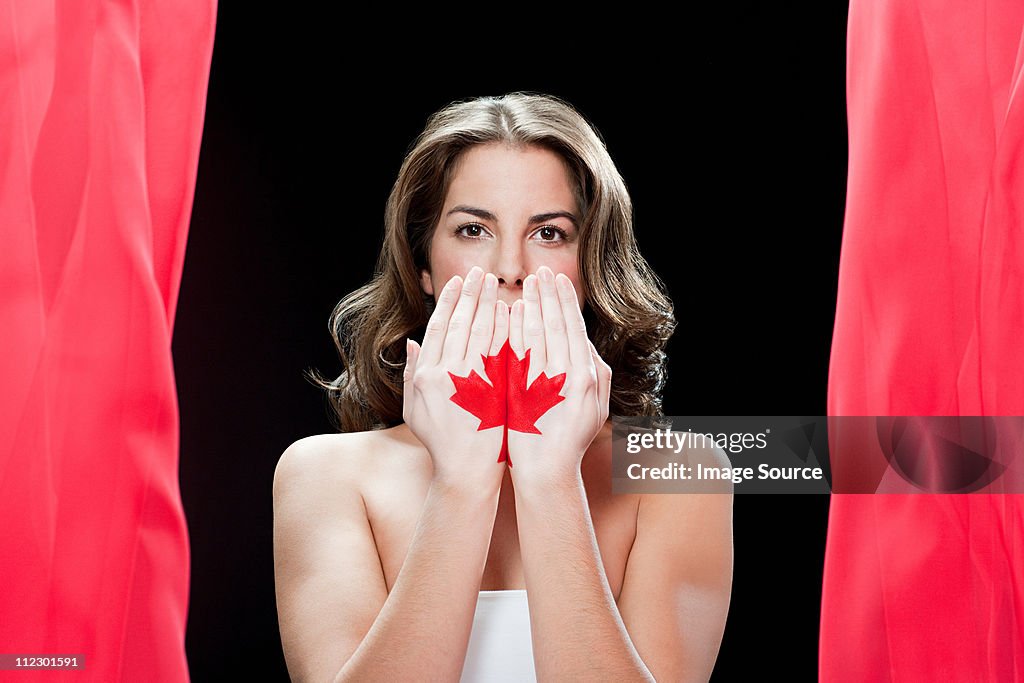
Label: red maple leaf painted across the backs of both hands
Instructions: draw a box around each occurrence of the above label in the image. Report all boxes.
[449,340,565,467]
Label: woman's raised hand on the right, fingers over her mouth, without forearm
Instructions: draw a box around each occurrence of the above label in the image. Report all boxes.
[508,266,611,481]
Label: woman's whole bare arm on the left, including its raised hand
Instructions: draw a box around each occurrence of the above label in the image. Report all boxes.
[274,267,508,681]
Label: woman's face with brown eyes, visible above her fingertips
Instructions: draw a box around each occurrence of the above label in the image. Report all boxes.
[421,142,584,307]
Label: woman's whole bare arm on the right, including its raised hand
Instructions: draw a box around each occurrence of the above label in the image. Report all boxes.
[509,266,732,681]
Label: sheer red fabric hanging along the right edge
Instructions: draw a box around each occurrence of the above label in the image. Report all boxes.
[819,0,1024,681]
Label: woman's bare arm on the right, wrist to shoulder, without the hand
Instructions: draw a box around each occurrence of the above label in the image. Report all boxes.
[516,456,732,681]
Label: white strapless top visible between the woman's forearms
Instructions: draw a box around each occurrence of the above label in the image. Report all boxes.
[460,589,537,683]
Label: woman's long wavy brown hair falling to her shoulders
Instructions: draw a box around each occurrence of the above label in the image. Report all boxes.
[310,92,676,431]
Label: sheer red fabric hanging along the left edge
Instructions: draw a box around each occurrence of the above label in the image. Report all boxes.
[0,0,216,681]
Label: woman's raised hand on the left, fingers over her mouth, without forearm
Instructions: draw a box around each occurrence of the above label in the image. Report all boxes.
[402,266,509,490]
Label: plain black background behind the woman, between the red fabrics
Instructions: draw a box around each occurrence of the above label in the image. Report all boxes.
[173,2,847,681]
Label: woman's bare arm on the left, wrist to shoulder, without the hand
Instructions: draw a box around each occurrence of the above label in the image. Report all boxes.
[273,434,500,681]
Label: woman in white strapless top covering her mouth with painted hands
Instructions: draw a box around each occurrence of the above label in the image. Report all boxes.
[273,93,732,681]
